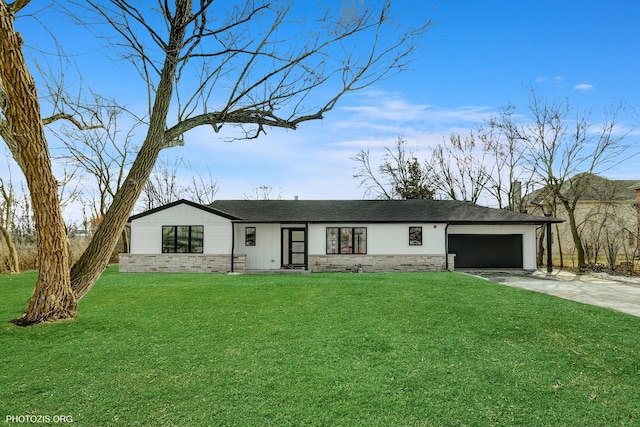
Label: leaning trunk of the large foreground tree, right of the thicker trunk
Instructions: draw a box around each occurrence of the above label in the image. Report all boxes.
[71,0,192,299]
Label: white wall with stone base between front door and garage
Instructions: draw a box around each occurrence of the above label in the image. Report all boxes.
[308,223,453,272]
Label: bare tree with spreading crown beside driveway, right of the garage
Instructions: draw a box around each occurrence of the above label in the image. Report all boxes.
[498,90,629,268]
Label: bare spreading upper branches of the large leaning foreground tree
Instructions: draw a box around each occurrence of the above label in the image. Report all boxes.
[80,0,430,139]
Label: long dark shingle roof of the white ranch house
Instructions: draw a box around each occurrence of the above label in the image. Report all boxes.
[209,199,561,224]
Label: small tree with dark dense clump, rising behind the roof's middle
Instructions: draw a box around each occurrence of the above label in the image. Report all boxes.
[352,137,433,199]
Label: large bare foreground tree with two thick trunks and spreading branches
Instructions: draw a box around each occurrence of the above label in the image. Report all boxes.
[0,0,429,325]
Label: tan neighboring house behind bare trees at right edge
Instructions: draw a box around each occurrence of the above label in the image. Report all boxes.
[524,174,640,263]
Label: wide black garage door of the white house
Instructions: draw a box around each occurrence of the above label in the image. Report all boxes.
[448,234,523,268]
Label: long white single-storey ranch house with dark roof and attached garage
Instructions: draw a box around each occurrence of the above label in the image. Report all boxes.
[120,200,561,273]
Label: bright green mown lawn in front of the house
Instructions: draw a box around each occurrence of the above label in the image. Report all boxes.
[0,267,640,426]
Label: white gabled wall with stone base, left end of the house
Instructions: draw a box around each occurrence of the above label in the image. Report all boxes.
[120,204,235,272]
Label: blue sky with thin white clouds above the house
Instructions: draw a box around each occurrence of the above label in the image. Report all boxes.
[8,0,640,217]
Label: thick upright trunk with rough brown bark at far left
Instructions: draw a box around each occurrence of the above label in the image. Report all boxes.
[0,2,77,326]
